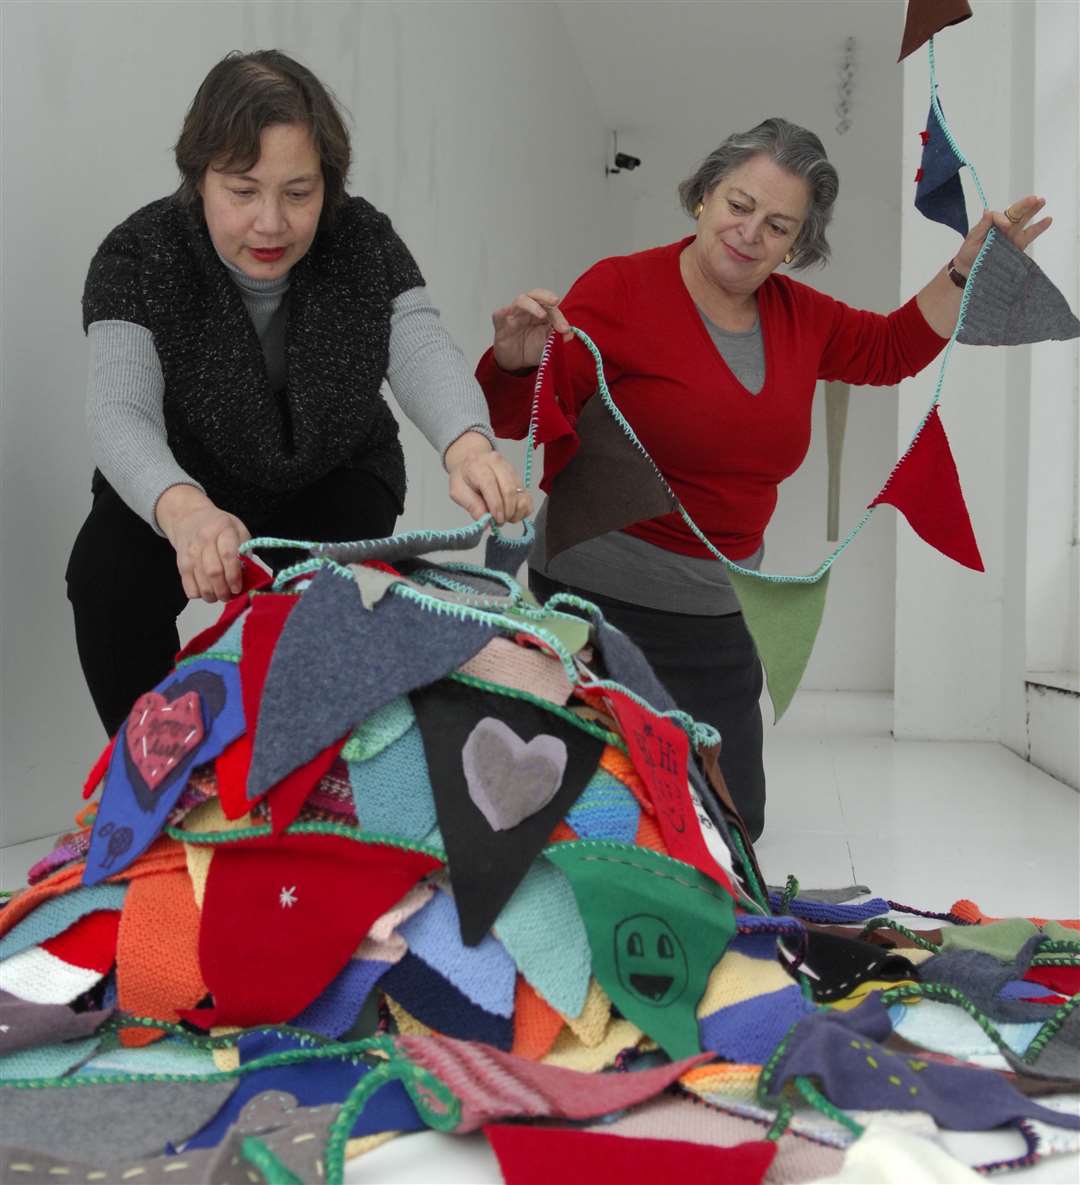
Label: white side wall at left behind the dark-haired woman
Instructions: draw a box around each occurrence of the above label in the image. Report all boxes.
[0,2,628,845]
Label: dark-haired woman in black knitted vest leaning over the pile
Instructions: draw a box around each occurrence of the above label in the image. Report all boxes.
[66,50,530,735]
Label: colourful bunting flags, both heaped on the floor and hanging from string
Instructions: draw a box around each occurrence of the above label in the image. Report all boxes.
[0,5,1080,1185]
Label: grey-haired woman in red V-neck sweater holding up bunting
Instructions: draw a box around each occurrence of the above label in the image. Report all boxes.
[477,119,1050,838]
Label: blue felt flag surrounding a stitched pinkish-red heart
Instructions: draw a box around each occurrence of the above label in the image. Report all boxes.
[83,659,244,885]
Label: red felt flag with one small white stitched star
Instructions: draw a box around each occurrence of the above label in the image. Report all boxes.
[183,834,439,1027]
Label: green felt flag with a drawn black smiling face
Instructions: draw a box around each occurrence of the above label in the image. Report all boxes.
[547,841,735,1058]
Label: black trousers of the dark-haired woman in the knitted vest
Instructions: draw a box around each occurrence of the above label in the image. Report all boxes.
[66,469,398,736]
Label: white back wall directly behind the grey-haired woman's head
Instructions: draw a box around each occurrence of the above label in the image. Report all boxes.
[562,0,914,691]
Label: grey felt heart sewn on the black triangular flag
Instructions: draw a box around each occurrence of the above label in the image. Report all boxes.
[461,716,567,831]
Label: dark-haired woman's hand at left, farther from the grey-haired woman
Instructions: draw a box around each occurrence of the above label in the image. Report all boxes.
[154,486,251,604]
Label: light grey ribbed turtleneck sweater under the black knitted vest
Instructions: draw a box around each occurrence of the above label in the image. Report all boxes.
[87,261,494,534]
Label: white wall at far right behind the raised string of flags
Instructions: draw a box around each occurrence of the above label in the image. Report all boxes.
[895,2,1078,744]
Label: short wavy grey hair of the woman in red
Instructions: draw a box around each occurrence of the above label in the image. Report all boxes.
[679,116,841,268]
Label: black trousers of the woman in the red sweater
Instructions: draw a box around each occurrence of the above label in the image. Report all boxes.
[529,568,765,839]
